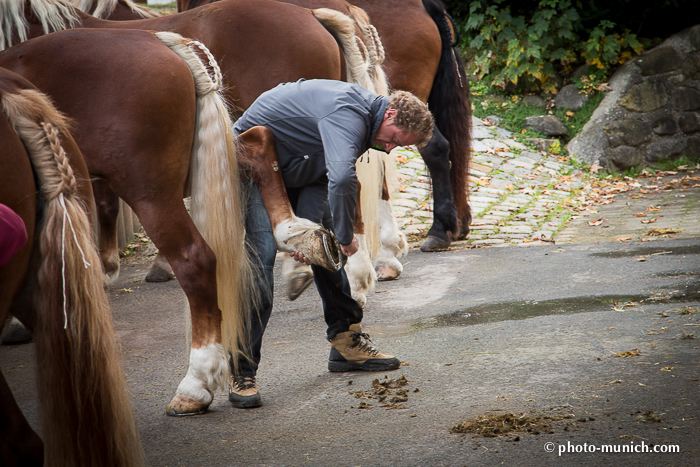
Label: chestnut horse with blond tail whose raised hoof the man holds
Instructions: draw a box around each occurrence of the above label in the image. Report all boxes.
[0,29,340,415]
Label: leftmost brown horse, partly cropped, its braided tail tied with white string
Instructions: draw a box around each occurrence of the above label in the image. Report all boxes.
[0,69,144,467]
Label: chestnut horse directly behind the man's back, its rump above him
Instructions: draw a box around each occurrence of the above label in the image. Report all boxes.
[16,0,386,306]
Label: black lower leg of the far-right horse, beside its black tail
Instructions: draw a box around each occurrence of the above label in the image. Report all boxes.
[420,127,460,251]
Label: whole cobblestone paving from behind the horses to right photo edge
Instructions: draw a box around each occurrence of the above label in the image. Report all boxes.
[394,118,700,248]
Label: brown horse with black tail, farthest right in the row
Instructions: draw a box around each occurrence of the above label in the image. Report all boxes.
[177,0,471,251]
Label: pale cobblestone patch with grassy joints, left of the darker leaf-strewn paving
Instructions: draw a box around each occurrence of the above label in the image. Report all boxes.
[394,117,581,247]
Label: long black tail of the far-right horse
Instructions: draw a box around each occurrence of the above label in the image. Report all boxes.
[423,0,472,236]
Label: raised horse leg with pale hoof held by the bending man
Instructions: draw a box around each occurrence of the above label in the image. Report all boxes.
[238,127,342,271]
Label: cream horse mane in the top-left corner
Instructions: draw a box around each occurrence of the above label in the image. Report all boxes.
[0,0,80,50]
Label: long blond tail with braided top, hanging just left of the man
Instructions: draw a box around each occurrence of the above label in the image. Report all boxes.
[155,32,255,376]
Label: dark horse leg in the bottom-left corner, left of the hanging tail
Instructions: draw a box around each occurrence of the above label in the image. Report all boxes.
[0,372,44,467]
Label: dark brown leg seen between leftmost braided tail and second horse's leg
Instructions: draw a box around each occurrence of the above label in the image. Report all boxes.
[92,180,119,285]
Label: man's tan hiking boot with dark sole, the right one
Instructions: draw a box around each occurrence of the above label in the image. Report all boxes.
[328,324,401,371]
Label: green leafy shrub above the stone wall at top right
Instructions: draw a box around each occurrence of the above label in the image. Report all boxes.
[459,0,642,92]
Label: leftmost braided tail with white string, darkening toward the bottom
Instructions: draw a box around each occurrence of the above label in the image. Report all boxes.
[2,90,144,466]
